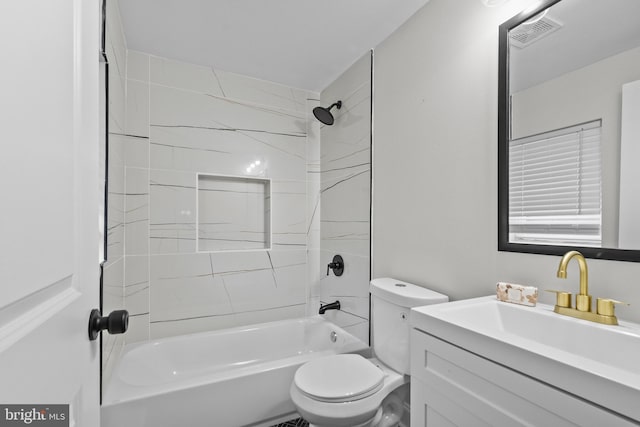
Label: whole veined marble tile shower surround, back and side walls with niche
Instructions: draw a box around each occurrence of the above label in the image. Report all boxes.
[105,10,371,354]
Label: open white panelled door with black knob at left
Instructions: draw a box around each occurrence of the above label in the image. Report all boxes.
[0,0,100,427]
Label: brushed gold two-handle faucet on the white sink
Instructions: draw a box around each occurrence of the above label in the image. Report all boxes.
[551,251,624,325]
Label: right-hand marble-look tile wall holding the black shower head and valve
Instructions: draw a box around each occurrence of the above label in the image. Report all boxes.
[309,53,372,342]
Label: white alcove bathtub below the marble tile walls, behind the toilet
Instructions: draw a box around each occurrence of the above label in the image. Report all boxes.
[101,316,368,427]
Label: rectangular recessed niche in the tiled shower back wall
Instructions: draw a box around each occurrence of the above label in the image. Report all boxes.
[197,174,271,252]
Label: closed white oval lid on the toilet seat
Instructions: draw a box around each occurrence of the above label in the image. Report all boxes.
[293,354,384,402]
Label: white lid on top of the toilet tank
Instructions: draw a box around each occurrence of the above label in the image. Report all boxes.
[369,277,449,307]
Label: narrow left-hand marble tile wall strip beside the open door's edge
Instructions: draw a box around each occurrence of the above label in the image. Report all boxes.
[102,1,127,392]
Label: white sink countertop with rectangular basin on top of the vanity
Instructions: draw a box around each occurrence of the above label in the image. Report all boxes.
[411,296,640,420]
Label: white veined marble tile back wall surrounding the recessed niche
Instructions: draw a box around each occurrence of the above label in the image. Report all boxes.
[124,51,320,342]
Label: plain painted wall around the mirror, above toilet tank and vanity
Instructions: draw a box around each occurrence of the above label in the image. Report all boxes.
[372,0,640,321]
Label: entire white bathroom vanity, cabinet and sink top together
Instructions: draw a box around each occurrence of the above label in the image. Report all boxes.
[410,295,640,427]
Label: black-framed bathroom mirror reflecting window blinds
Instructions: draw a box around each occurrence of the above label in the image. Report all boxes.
[498,0,640,262]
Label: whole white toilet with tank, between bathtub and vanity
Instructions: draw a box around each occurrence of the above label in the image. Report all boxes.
[290,278,449,427]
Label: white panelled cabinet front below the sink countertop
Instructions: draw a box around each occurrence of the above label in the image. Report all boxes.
[411,329,637,427]
